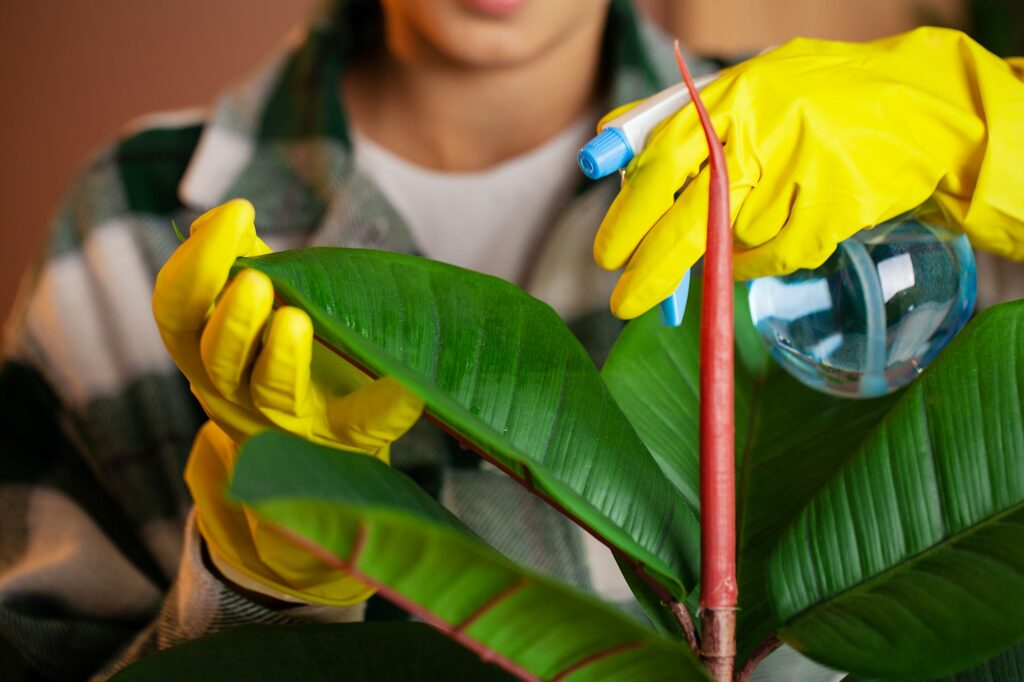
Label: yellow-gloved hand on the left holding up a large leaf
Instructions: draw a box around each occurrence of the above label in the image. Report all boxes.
[153,200,423,604]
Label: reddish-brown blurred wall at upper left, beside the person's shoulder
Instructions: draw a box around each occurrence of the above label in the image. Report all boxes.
[0,0,315,318]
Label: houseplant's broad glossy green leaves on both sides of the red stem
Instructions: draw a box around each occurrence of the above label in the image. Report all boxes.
[112,249,1024,680]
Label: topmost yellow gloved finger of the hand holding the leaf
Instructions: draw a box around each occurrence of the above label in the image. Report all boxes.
[153,199,270,337]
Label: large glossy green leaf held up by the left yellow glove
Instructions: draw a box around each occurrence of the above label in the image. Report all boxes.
[236,249,699,598]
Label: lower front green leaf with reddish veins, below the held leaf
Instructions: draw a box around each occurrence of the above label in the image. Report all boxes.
[229,432,705,682]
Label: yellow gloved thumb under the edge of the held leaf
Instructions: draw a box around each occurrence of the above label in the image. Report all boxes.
[328,377,423,454]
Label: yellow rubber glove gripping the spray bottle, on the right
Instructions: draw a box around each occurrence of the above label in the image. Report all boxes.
[594,29,1024,318]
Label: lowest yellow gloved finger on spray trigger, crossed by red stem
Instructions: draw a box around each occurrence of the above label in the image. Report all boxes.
[611,155,754,319]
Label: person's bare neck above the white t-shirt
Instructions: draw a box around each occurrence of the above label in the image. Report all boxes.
[342,17,604,172]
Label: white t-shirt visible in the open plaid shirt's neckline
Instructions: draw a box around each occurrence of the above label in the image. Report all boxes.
[352,115,594,284]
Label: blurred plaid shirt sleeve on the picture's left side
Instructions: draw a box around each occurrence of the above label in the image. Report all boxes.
[0,139,361,679]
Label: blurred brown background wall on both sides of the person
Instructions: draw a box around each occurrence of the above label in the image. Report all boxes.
[0,0,958,318]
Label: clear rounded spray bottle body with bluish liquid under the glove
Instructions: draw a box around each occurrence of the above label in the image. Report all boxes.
[750,209,977,398]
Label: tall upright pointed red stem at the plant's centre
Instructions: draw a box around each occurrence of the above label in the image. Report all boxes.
[676,41,738,679]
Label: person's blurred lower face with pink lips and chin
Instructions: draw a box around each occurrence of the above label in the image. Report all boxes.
[381,0,609,69]
